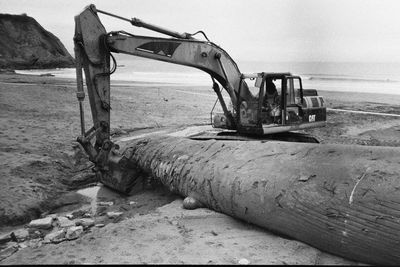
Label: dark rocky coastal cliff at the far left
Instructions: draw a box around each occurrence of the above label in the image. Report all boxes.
[0,14,74,69]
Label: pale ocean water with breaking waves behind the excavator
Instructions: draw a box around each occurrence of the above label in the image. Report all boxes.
[17,55,400,95]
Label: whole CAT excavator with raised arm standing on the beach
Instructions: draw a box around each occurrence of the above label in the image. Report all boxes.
[74,5,326,195]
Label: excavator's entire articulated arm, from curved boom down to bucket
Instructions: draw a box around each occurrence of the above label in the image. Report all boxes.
[74,5,254,191]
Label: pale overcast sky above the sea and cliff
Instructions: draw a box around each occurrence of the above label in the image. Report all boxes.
[0,0,400,62]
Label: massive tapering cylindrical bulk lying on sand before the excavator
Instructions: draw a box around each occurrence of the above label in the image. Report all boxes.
[113,137,400,265]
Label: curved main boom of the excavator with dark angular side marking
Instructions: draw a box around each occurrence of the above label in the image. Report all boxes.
[107,32,247,106]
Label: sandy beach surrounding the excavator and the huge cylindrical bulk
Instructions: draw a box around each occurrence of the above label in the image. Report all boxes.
[0,71,400,265]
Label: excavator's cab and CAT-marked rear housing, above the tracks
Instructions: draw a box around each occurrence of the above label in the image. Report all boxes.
[236,72,326,134]
